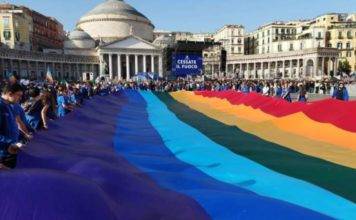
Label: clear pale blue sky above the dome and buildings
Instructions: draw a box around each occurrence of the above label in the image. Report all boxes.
[0,0,356,33]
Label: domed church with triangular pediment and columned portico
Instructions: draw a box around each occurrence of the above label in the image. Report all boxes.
[64,0,163,80]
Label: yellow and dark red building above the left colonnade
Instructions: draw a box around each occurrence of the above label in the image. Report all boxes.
[0,4,64,51]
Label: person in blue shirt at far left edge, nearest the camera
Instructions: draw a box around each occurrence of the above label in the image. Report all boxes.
[0,83,23,168]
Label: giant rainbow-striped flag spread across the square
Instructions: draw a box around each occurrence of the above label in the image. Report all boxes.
[0,90,356,220]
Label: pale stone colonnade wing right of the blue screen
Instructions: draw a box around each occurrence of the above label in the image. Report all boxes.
[226,48,339,79]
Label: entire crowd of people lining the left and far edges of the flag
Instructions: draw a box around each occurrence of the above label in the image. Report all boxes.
[0,76,349,169]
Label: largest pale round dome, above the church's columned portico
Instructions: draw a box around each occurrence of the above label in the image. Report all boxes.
[77,0,154,42]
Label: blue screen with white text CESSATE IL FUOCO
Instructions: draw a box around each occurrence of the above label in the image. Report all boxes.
[172,54,203,76]
